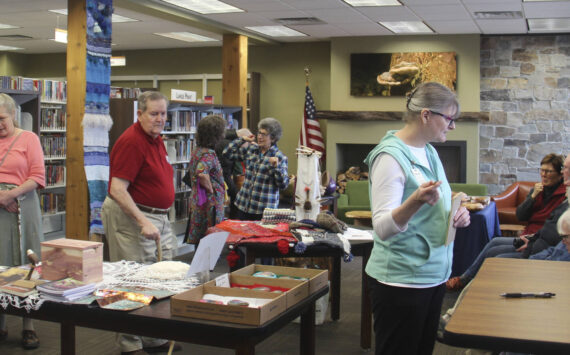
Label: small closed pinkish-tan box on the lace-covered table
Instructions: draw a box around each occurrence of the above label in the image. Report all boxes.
[41,238,103,283]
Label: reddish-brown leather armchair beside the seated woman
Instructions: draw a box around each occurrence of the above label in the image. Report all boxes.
[491,181,536,225]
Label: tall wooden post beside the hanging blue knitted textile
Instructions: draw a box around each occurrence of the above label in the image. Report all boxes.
[65,0,89,240]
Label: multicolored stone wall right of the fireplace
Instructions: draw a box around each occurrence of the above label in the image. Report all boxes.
[479,35,570,195]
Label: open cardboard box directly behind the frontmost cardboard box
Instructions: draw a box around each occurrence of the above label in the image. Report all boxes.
[204,273,309,308]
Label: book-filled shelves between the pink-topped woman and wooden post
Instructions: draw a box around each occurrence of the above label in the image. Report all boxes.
[38,80,67,239]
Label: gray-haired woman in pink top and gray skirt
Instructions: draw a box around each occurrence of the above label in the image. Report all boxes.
[0,94,45,349]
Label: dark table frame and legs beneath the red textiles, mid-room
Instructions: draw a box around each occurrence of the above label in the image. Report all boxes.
[238,240,373,349]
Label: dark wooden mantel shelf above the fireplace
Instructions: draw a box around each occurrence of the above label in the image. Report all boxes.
[315,111,489,122]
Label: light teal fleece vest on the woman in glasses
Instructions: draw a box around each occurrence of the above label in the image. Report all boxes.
[364,131,453,284]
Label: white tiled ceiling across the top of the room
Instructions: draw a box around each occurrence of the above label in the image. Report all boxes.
[0,0,570,53]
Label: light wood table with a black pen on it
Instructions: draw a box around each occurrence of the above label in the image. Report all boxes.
[444,258,570,354]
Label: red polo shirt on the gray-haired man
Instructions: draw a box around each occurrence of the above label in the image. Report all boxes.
[109,122,174,209]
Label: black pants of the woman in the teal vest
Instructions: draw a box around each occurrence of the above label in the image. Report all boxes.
[368,277,445,355]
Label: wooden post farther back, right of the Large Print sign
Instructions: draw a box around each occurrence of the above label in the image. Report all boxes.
[220,34,248,127]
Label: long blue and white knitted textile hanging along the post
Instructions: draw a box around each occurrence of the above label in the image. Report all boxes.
[83,0,113,238]
